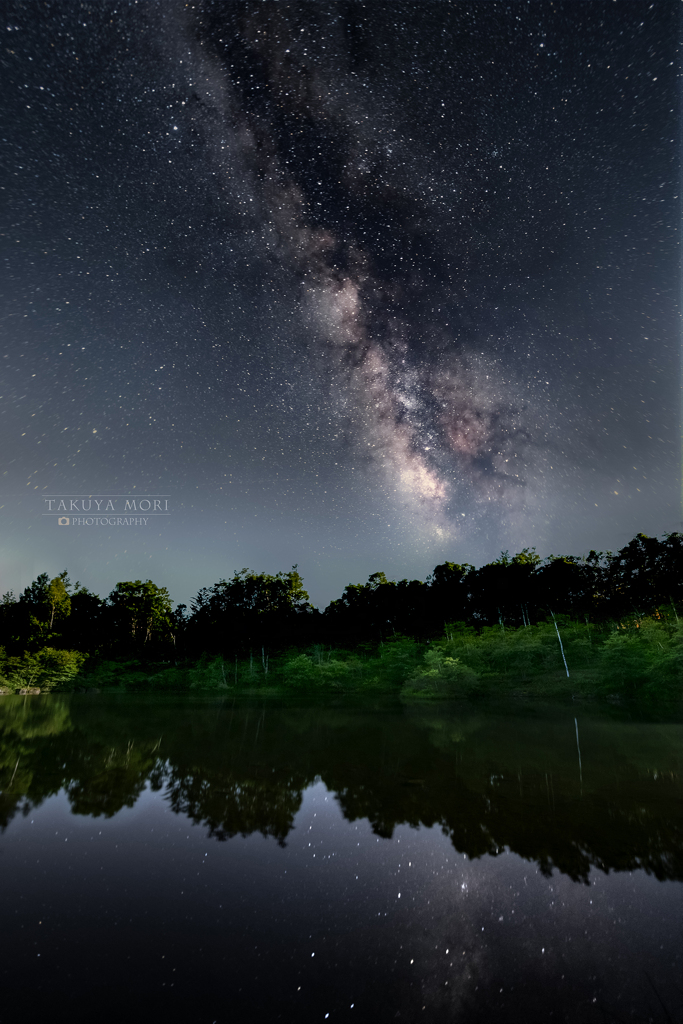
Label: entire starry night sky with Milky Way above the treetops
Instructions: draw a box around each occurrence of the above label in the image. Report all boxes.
[0,0,681,606]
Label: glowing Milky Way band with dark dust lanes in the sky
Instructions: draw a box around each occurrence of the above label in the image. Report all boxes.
[163,4,549,534]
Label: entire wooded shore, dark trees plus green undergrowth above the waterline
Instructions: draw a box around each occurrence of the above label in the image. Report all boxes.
[0,532,683,699]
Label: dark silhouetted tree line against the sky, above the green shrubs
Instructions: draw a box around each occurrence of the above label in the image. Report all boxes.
[0,532,683,659]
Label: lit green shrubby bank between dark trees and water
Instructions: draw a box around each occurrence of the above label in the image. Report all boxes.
[0,612,683,700]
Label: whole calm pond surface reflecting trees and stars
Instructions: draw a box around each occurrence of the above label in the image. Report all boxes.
[0,694,683,1024]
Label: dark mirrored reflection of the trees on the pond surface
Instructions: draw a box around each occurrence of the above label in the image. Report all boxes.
[0,694,683,882]
